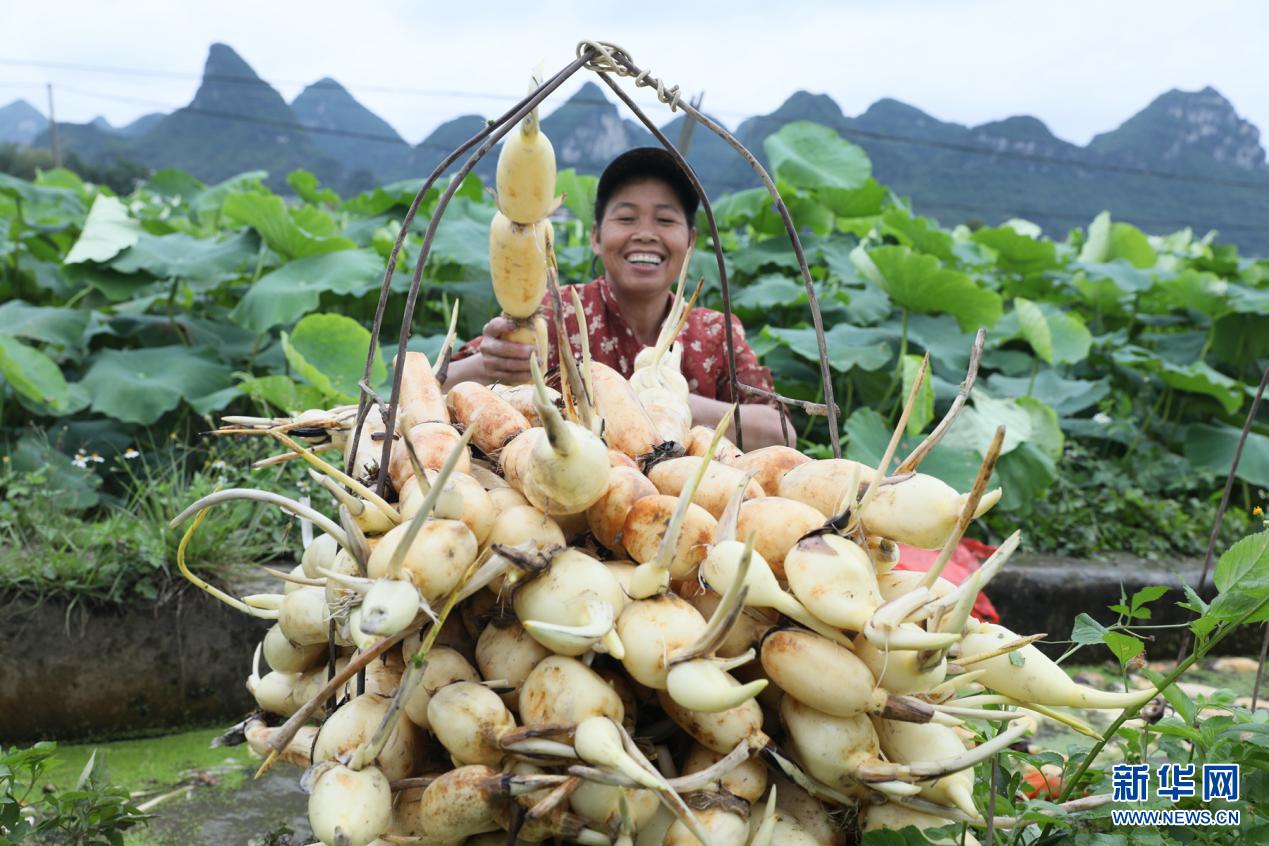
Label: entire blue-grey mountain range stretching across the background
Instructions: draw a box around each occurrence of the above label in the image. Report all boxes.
[9,44,1269,255]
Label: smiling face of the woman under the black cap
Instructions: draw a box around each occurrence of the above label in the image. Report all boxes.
[590,179,693,297]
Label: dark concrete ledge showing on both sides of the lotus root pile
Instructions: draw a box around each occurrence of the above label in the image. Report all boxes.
[0,554,1261,743]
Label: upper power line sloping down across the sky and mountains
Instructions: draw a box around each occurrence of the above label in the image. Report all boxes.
[9,58,1269,190]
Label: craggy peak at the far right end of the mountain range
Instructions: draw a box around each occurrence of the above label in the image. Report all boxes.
[1089,88,1265,172]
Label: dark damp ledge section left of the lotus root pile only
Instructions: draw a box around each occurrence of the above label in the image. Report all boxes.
[0,575,273,743]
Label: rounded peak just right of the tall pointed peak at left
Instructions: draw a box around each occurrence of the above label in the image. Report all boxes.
[291,76,411,190]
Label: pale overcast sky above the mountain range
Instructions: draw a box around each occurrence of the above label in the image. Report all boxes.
[0,0,1269,145]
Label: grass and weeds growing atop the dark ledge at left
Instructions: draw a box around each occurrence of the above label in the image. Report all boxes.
[0,438,307,604]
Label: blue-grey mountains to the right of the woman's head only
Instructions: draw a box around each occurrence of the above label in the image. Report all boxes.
[694,88,1269,255]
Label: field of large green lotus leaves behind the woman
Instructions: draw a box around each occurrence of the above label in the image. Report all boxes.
[0,124,1269,606]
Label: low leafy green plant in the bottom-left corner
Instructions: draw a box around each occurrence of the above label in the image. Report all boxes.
[0,741,150,846]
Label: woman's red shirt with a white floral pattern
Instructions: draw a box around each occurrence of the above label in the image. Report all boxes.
[454,277,775,405]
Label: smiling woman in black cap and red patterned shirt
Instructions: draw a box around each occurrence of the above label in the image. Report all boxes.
[445,147,793,449]
